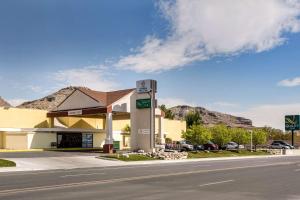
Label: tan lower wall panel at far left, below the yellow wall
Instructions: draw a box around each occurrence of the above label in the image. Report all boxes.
[4,133,28,150]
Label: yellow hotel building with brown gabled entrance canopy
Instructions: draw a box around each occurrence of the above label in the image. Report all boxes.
[0,88,186,149]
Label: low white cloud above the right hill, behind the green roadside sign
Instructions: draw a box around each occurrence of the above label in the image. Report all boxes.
[232,103,300,130]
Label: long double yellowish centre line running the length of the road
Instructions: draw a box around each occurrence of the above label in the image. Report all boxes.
[0,162,293,196]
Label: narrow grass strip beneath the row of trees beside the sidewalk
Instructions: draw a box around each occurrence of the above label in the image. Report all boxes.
[188,150,270,158]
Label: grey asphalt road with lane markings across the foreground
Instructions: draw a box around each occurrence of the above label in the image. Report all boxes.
[0,157,300,200]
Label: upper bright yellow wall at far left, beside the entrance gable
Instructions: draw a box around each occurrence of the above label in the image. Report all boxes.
[0,108,49,128]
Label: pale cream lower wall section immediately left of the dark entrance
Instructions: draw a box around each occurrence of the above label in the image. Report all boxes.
[27,133,56,149]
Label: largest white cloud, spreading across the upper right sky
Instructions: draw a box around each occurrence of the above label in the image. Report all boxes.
[116,0,300,72]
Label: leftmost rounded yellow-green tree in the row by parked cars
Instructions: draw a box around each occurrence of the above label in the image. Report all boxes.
[182,125,212,144]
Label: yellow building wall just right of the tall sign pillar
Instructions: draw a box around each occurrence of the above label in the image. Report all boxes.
[164,119,186,141]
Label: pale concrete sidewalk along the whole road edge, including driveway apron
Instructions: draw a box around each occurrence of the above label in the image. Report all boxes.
[0,155,299,172]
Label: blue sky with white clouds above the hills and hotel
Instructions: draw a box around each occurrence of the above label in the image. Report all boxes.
[0,0,300,129]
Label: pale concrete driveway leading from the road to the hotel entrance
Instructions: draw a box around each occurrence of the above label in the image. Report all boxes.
[0,152,123,172]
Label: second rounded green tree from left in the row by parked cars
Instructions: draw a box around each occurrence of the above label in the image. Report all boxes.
[211,125,232,147]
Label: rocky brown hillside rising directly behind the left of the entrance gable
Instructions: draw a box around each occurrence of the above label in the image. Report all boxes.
[17,87,76,111]
